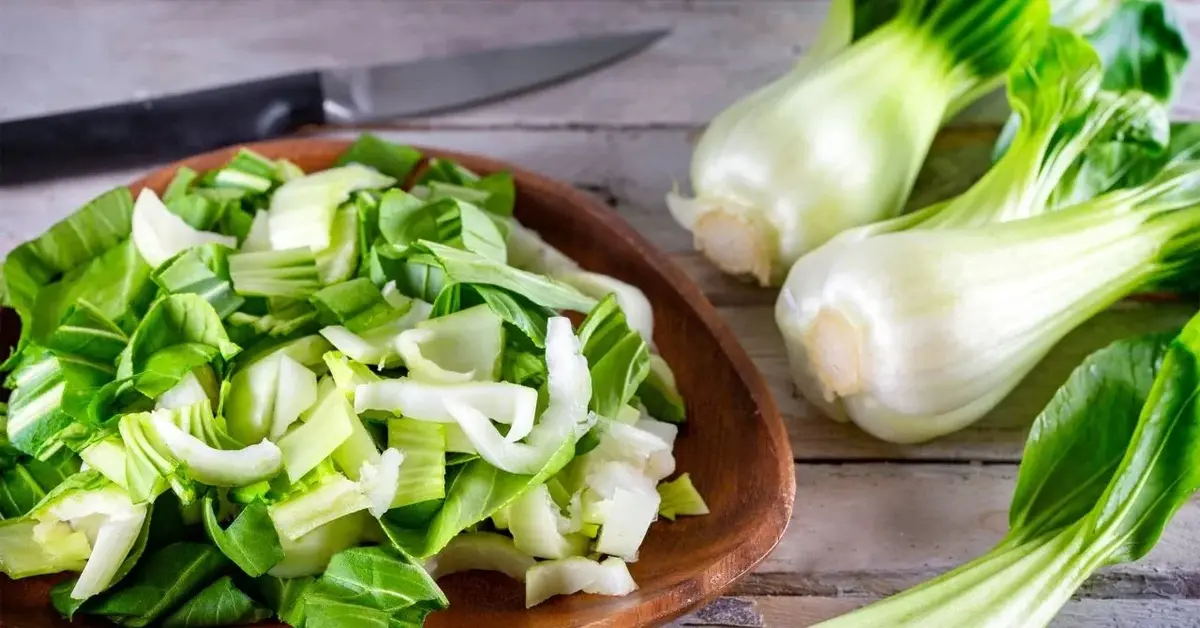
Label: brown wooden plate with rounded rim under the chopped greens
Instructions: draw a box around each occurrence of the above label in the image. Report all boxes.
[0,139,796,628]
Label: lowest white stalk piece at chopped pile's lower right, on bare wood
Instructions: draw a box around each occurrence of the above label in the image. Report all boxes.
[526,556,637,609]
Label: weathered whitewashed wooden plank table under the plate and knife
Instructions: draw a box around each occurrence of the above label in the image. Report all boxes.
[7,0,1200,628]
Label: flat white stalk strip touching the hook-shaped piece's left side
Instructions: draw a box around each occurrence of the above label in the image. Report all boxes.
[354,378,538,425]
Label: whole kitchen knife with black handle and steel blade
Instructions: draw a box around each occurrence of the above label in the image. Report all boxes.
[0,30,666,185]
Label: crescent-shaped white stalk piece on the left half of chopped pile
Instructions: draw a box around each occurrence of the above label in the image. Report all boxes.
[152,413,283,486]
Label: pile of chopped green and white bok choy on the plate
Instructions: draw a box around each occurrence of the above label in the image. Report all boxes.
[0,134,708,628]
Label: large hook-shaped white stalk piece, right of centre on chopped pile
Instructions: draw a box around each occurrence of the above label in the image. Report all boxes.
[443,317,595,474]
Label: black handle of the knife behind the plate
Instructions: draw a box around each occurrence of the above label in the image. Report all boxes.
[0,72,325,185]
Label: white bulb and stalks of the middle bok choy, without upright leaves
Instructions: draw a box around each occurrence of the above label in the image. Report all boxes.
[775,162,1200,443]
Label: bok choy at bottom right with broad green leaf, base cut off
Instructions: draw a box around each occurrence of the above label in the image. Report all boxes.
[820,317,1200,628]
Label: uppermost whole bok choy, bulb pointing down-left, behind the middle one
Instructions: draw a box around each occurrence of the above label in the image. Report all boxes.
[667,0,1049,285]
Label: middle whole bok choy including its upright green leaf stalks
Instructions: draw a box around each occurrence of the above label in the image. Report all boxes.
[775,29,1200,443]
